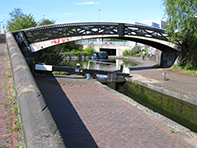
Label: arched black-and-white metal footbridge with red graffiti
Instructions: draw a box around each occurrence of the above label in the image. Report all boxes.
[10,22,180,65]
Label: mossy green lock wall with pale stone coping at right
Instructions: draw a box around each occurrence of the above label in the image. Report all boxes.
[118,77,197,132]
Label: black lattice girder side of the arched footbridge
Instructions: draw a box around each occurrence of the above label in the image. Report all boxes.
[22,22,168,44]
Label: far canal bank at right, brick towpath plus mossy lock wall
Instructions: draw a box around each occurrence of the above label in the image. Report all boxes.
[113,57,197,132]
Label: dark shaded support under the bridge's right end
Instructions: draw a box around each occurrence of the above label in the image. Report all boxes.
[160,51,179,68]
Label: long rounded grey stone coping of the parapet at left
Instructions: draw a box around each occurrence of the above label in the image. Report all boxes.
[6,32,65,148]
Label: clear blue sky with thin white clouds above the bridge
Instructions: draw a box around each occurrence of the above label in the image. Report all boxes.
[0,0,164,26]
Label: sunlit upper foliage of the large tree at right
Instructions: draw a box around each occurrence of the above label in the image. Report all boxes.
[164,0,197,42]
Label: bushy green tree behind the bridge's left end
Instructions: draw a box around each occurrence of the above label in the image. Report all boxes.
[7,8,37,31]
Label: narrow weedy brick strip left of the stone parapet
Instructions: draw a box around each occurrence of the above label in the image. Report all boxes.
[0,44,11,148]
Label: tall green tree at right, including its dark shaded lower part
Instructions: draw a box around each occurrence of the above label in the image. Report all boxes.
[163,0,197,68]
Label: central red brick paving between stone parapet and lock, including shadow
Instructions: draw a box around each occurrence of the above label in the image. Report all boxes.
[37,80,190,148]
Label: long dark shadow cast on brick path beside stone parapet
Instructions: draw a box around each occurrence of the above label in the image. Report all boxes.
[36,76,98,148]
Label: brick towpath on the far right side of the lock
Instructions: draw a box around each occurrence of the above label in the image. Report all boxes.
[130,57,197,96]
